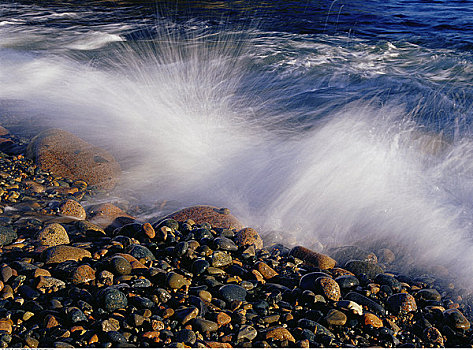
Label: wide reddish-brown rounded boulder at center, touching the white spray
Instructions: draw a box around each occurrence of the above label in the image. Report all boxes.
[167,205,243,230]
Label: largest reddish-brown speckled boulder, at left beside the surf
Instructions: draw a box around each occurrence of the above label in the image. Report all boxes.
[26,129,121,190]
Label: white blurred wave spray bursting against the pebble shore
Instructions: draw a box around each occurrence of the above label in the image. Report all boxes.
[0,17,473,286]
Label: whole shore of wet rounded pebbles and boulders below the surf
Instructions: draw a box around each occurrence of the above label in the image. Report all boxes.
[0,129,473,348]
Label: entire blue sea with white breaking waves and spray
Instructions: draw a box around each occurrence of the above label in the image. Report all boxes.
[0,0,473,288]
